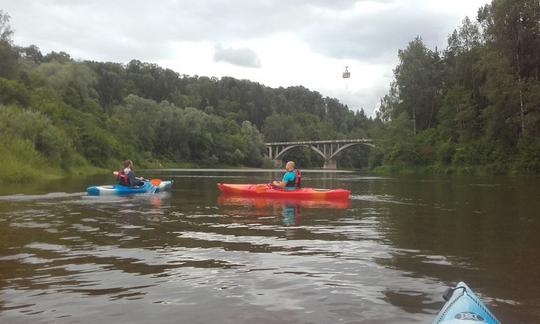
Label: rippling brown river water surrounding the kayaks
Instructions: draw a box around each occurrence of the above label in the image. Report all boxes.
[0,170,540,323]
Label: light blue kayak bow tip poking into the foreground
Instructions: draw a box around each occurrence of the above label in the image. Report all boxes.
[433,282,500,324]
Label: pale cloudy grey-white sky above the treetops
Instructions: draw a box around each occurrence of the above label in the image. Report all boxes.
[0,0,490,115]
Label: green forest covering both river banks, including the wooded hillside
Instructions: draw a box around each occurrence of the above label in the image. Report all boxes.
[0,0,540,182]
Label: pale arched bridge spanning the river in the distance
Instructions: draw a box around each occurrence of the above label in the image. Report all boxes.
[265,138,376,169]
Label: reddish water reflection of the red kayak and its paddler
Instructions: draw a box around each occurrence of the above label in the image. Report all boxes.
[218,195,350,226]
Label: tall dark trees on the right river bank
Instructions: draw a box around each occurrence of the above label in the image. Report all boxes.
[378,0,540,173]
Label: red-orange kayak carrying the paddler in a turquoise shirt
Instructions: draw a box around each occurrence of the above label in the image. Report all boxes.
[218,183,351,200]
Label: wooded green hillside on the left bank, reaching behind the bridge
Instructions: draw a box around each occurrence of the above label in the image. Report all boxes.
[0,12,368,181]
